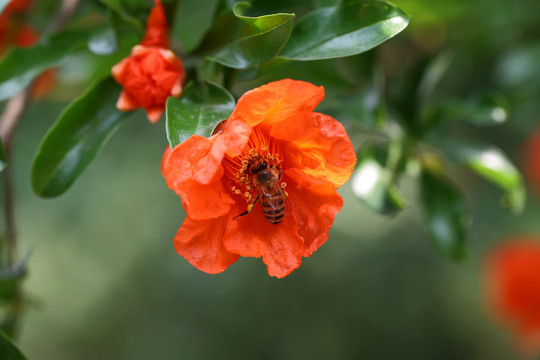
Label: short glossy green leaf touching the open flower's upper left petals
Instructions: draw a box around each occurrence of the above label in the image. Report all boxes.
[166,81,235,148]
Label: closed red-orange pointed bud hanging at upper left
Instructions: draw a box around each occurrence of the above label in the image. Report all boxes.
[112,0,186,123]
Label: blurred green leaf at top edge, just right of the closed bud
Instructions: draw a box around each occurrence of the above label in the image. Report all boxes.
[172,0,219,53]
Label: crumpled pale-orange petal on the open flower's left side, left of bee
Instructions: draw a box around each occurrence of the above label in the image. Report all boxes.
[161,139,234,220]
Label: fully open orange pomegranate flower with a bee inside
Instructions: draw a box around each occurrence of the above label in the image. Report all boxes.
[161,79,356,278]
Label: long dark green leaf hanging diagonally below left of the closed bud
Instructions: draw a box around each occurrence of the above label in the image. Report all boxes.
[31,78,130,197]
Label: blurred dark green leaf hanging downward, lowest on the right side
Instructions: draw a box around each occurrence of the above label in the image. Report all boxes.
[420,170,469,260]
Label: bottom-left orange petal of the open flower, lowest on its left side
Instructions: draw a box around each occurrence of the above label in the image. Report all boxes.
[174,215,239,274]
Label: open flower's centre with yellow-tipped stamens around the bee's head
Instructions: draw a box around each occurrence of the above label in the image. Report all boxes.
[223,126,285,204]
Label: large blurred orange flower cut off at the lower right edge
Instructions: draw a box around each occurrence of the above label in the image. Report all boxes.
[486,237,540,355]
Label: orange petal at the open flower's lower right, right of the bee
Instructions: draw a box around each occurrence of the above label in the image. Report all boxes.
[283,169,343,257]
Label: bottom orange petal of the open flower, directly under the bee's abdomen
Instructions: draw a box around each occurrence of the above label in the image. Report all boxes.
[223,203,304,278]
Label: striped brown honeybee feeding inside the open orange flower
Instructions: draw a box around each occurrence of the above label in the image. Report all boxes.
[235,159,287,225]
